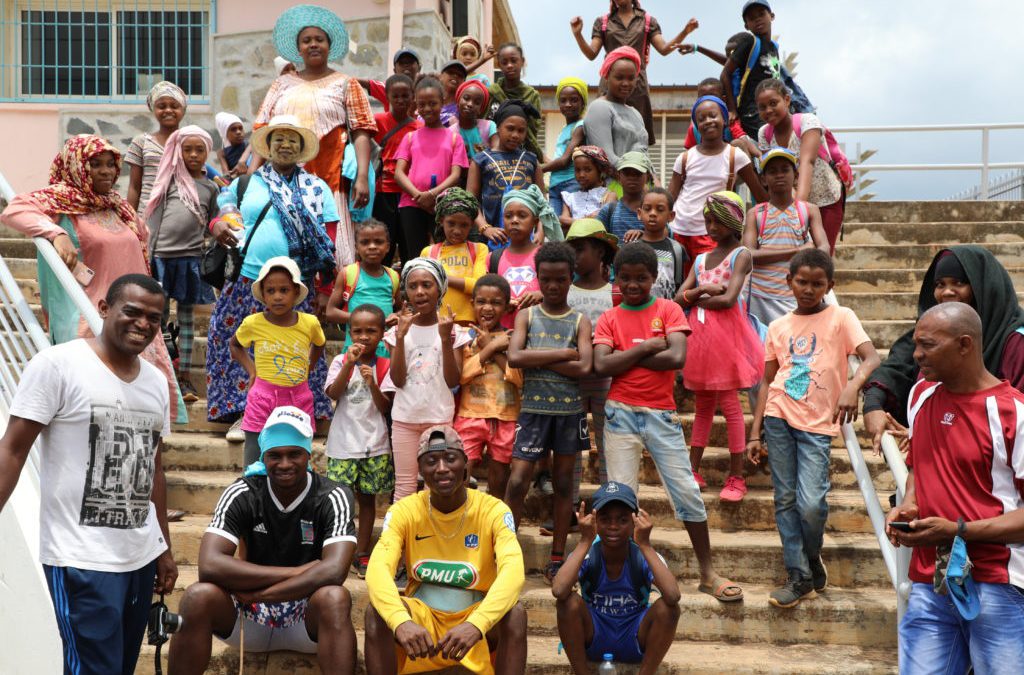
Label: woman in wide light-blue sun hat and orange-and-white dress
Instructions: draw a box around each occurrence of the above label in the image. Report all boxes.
[253,5,377,266]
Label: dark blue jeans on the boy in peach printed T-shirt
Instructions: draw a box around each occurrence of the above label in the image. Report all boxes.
[764,417,831,579]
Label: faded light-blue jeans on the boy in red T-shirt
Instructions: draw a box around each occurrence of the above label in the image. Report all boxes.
[604,400,708,522]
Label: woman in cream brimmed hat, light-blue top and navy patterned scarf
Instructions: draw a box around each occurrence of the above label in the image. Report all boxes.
[206,115,338,441]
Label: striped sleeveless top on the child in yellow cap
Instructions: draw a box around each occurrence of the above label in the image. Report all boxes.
[751,202,811,299]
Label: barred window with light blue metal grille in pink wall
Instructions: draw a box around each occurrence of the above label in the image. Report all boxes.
[0,0,211,102]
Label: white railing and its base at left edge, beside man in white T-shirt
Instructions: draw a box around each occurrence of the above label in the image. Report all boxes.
[0,173,64,672]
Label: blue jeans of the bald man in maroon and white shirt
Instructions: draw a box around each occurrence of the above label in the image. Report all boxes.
[899,583,1024,675]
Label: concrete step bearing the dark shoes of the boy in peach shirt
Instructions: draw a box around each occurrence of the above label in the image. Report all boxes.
[157,566,896,648]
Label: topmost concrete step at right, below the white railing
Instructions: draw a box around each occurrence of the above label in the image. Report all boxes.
[844,201,1024,226]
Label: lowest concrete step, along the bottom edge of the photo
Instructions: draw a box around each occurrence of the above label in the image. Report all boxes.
[135,621,896,675]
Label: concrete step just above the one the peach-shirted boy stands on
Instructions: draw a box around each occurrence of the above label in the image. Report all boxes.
[170,515,891,588]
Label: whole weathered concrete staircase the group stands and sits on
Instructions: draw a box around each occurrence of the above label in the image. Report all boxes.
[6,202,1024,675]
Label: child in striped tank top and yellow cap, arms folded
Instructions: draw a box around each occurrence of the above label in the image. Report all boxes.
[743,147,828,327]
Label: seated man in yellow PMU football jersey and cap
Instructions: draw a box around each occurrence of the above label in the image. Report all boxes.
[364,425,526,675]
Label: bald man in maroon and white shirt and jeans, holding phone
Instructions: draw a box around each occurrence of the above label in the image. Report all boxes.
[886,302,1024,674]
